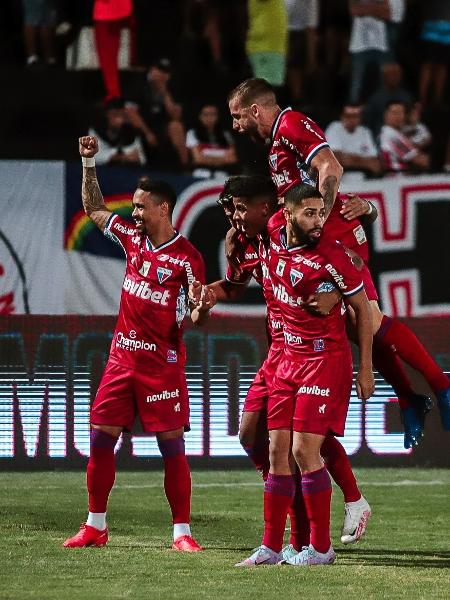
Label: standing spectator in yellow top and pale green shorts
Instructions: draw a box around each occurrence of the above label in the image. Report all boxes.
[246,0,287,87]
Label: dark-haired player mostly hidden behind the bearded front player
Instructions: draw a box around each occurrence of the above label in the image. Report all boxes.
[195,175,371,559]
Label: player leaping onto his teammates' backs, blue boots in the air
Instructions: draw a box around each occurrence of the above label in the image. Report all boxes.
[228,79,450,448]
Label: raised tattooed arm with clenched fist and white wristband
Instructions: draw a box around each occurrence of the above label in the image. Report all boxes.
[78,135,111,231]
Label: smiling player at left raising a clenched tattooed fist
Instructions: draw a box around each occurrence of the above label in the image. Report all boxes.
[64,136,215,552]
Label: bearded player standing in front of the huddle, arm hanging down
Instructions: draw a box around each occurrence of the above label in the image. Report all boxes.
[238,184,374,566]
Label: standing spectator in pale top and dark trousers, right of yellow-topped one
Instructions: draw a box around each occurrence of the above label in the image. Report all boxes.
[284,0,319,102]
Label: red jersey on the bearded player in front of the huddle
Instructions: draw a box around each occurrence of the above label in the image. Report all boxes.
[269,227,364,360]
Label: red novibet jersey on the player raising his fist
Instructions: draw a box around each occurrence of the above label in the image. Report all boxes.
[104,214,205,371]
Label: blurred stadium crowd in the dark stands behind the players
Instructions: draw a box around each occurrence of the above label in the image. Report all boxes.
[2,0,450,177]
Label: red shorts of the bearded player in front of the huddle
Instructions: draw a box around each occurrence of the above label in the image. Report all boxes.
[267,348,353,435]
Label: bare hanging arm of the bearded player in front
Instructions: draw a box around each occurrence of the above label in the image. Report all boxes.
[347,290,375,400]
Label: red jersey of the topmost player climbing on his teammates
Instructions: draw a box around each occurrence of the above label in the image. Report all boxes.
[269,108,329,197]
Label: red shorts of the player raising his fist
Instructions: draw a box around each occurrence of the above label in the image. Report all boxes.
[91,361,189,432]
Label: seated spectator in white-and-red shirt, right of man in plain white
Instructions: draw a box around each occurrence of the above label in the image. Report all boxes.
[380,101,430,173]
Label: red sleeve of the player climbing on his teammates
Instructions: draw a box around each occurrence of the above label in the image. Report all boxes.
[279,111,329,165]
